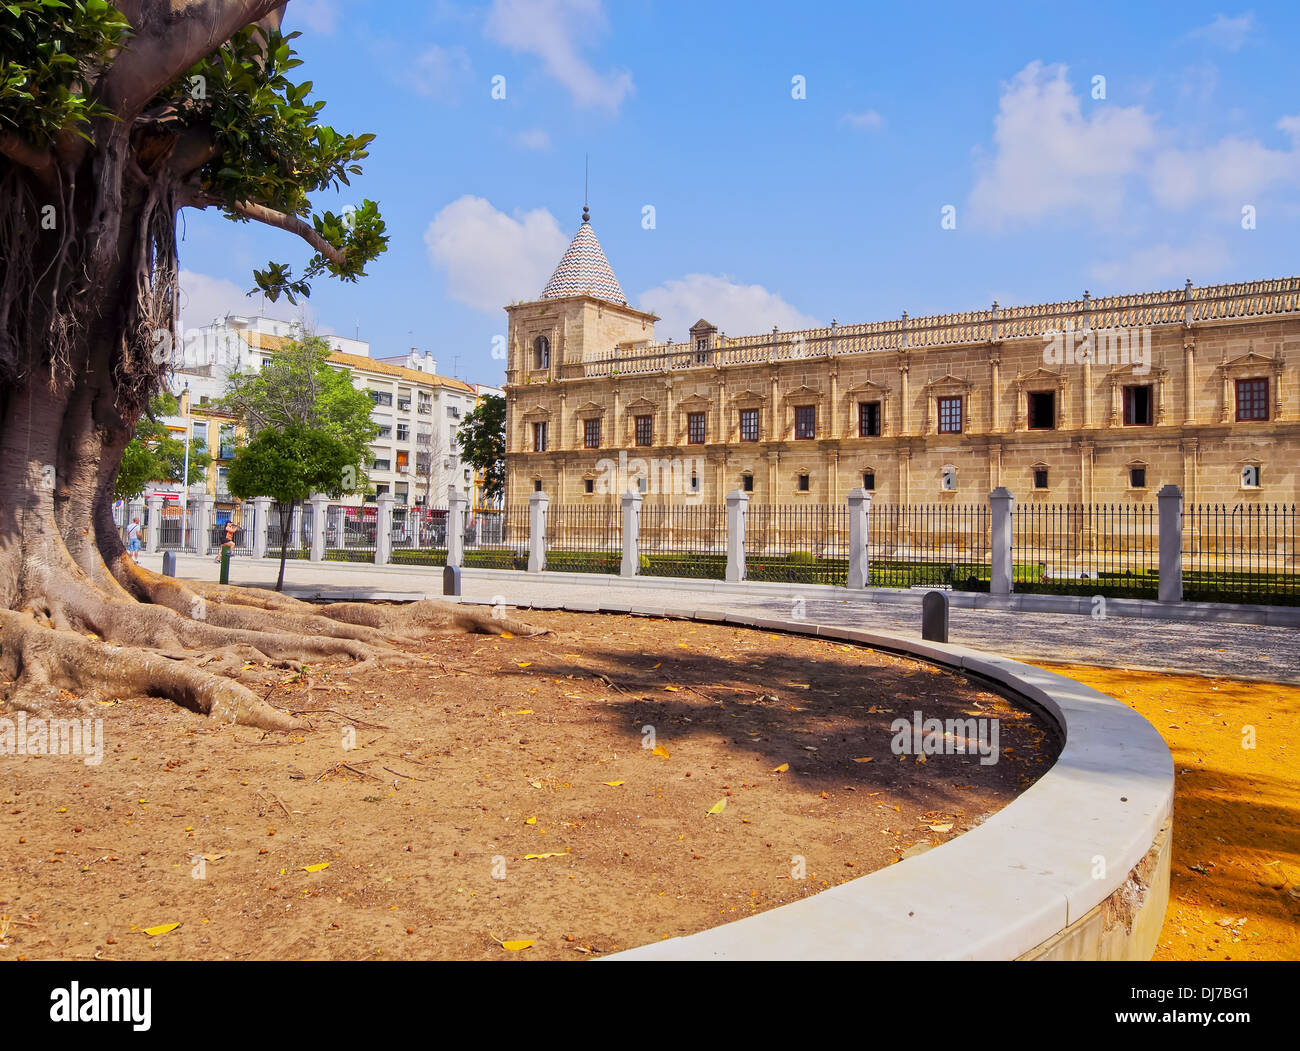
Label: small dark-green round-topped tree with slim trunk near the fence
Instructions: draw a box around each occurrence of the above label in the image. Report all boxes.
[228,424,355,591]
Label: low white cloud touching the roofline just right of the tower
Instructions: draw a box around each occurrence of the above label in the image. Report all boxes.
[638,273,822,339]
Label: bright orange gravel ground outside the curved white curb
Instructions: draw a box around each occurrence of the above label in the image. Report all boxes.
[1045,665,1300,960]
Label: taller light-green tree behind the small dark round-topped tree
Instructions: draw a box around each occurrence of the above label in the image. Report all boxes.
[221,334,380,492]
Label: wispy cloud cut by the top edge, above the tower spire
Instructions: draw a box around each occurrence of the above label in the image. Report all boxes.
[485,0,632,112]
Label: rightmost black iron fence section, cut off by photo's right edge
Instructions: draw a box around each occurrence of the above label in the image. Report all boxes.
[1183,503,1300,605]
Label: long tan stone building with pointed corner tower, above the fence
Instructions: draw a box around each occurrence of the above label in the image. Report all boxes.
[506,213,1300,505]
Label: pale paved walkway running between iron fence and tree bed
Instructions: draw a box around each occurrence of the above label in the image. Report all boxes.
[140,555,1300,684]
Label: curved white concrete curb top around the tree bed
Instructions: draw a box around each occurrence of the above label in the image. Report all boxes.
[483,604,1174,960]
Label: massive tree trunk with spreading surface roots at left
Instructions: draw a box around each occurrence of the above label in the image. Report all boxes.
[0,122,529,730]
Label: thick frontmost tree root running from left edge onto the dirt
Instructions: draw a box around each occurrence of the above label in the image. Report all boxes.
[0,610,303,730]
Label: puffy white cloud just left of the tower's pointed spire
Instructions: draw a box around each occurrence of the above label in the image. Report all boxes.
[424,195,569,313]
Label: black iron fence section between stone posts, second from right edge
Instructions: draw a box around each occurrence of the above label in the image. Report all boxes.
[1011,503,1160,598]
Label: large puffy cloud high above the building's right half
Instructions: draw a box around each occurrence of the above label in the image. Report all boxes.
[970,61,1156,228]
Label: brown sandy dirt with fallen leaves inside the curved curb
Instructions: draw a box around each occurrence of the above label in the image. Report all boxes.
[0,613,1055,960]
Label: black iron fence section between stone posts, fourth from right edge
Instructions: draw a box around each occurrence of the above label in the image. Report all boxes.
[745,503,849,587]
